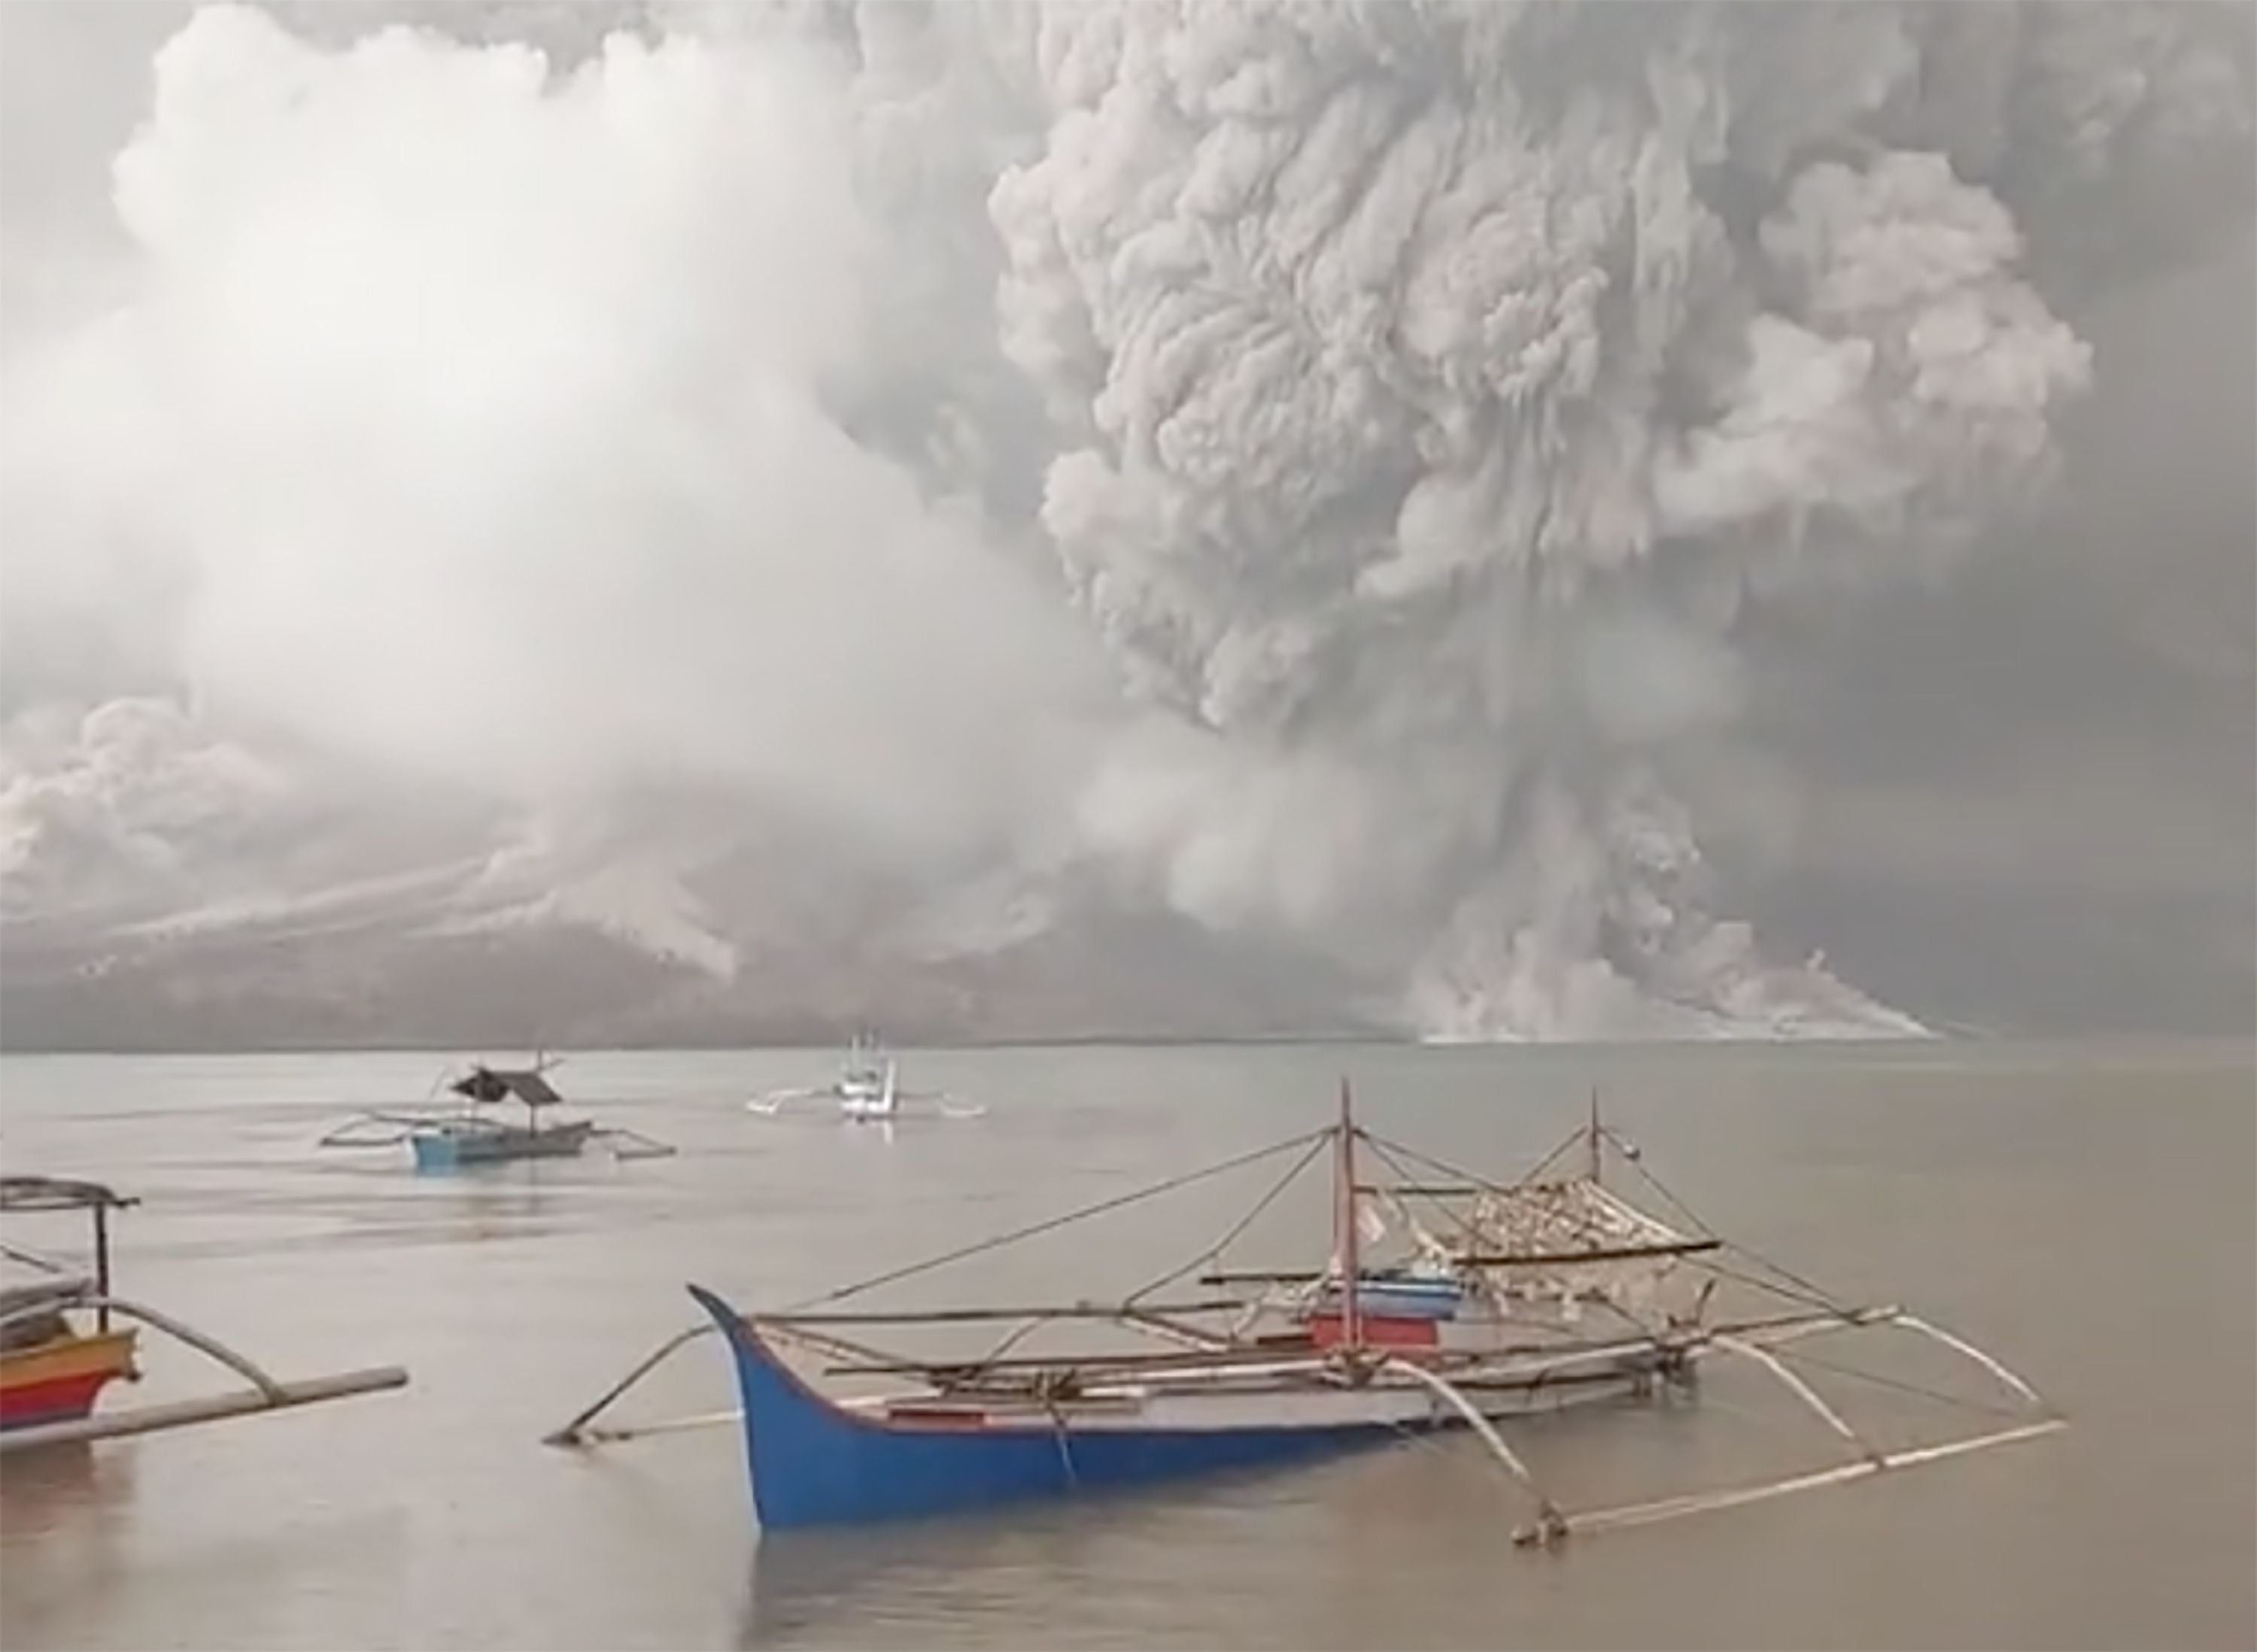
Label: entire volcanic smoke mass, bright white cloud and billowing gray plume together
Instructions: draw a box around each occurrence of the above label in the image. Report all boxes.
[0,0,2250,1036]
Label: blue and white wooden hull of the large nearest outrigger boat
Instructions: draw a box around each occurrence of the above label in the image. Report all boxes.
[691,1286,1650,1530]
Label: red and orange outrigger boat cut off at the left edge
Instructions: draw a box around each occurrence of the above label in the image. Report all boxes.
[0,1176,409,1453]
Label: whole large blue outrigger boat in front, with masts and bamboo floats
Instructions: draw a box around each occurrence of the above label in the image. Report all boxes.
[548,1083,2065,1544]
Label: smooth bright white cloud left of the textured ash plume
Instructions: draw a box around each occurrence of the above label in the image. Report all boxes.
[7,7,1110,871]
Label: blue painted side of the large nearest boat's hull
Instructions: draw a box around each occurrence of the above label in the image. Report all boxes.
[691,1284,1435,1530]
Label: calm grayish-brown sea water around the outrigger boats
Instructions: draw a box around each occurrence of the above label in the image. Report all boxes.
[0,1045,2257,1652]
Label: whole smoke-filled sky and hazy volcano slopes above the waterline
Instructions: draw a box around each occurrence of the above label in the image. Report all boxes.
[0,0,2257,1047]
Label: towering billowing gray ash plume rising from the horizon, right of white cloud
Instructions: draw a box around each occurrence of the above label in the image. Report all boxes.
[961,0,2250,1034]
